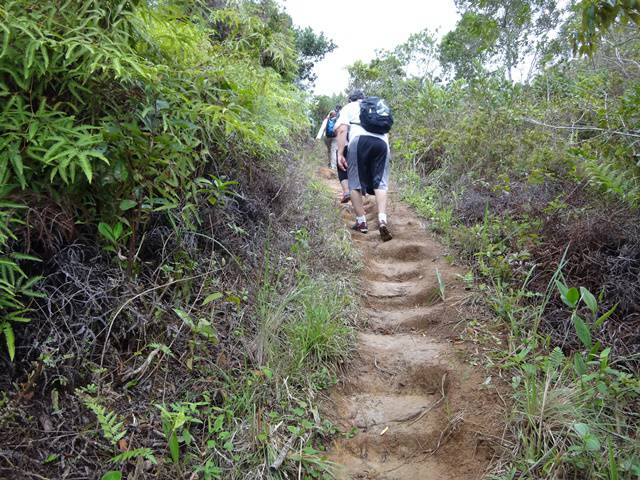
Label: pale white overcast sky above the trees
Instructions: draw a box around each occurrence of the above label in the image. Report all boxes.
[281,0,458,95]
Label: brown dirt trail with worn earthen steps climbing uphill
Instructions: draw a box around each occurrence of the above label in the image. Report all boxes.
[319,168,501,480]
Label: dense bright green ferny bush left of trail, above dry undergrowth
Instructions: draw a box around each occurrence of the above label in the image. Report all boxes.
[0,0,306,358]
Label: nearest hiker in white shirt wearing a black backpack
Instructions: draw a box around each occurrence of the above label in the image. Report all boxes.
[336,89,393,242]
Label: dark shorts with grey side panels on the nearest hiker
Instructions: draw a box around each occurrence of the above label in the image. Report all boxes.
[347,135,390,195]
